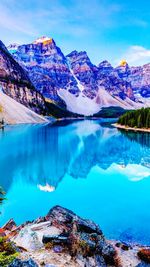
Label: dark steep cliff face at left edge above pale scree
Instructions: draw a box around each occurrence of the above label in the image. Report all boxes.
[0,41,46,114]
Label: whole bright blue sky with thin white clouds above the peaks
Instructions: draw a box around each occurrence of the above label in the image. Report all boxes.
[0,0,150,65]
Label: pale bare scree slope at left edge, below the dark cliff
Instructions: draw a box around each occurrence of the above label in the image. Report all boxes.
[0,91,48,124]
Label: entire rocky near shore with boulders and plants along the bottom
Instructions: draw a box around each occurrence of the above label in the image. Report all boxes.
[0,206,150,267]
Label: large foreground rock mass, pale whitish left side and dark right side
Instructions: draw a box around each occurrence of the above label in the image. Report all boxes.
[9,206,116,267]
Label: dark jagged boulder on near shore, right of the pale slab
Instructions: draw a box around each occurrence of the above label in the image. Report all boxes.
[42,206,116,266]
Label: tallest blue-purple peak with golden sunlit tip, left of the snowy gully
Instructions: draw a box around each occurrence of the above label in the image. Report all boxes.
[9,38,79,104]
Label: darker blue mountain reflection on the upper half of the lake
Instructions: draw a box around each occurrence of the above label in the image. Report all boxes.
[0,120,150,194]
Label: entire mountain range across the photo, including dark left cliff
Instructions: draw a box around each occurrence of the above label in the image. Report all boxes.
[0,37,150,119]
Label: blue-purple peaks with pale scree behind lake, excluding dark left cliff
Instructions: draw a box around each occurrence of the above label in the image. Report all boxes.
[8,37,150,116]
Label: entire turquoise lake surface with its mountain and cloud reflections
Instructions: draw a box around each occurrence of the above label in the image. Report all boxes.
[0,120,150,245]
